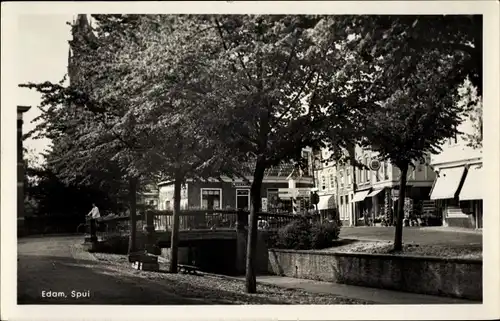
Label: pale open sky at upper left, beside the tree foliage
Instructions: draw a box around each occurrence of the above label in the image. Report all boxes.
[16,14,73,162]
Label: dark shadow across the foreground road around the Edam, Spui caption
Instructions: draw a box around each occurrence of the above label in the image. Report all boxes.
[18,254,283,305]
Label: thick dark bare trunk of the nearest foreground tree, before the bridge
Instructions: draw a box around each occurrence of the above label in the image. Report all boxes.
[245,162,266,293]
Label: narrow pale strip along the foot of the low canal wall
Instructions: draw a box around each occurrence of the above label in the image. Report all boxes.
[237,275,481,304]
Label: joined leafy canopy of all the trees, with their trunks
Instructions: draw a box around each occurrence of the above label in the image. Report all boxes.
[19,15,482,292]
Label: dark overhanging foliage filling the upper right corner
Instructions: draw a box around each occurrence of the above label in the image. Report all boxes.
[342,15,483,96]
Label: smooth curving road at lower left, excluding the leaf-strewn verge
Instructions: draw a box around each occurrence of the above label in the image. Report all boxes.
[18,236,204,305]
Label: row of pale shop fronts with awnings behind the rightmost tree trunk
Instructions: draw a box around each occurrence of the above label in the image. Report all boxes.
[315,146,436,226]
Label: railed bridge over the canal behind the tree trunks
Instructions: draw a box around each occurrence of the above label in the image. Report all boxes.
[87,210,332,273]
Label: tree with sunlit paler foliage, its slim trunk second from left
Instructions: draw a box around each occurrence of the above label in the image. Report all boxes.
[83,15,252,272]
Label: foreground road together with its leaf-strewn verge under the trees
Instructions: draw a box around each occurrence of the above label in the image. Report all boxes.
[18,236,373,305]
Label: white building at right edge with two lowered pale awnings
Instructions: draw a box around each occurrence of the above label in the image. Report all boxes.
[431,107,484,228]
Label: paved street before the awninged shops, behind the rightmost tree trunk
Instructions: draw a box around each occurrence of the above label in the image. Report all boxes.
[340,226,483,246]
